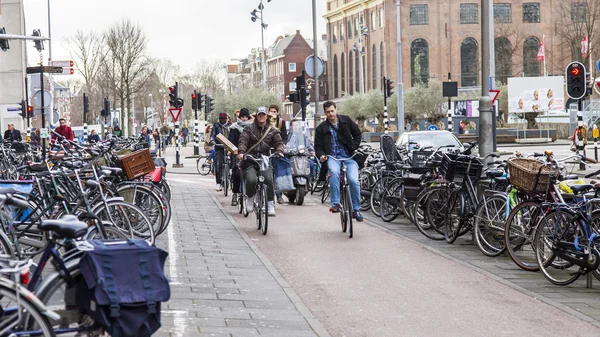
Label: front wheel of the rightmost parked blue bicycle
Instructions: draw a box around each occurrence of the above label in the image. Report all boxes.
[533,210,586,286]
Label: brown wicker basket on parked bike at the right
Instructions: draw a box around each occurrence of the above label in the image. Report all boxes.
[508,158,556,193]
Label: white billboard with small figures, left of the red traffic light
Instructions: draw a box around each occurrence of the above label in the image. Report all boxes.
[508,76,565,114]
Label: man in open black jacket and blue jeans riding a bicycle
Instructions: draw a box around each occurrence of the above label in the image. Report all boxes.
[315,101,363,222]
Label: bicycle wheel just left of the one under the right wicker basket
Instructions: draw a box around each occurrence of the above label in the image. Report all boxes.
[473,195,508,257]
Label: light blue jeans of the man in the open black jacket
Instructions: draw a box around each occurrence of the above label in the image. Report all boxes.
[327,158,360,211]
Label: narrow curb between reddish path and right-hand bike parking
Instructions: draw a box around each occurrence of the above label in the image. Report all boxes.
[311,195,600,328]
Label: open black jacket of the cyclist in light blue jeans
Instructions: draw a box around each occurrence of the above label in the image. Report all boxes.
[315,115,361,158]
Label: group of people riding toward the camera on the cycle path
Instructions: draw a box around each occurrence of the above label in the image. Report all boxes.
[204,101,363,222]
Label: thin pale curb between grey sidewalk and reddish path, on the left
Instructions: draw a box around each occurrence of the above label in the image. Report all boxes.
[207,191,331,337]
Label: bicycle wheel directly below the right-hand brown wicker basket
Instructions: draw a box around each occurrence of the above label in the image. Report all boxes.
[504,201,544,271]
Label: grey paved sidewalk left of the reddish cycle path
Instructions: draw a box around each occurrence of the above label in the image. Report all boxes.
[156,174,329,337]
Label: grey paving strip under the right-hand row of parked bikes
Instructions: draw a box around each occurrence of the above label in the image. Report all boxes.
[363,207,600,327]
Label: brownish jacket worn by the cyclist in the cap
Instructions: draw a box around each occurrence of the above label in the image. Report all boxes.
[238,122,285,157]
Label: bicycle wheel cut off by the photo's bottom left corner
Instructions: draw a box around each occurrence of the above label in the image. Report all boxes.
[0,286,56,337]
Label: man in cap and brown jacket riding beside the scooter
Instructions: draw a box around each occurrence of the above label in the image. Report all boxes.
[238,107,285,216]
